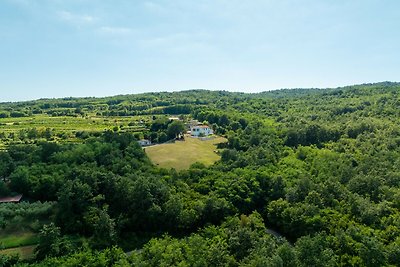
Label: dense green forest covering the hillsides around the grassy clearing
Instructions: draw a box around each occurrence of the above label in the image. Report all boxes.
[0,82,400,267]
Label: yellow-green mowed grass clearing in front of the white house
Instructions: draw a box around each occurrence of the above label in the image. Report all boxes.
[145,136,227,170]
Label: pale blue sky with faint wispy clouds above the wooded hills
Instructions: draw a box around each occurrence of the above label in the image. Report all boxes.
[0,0,400,101]
